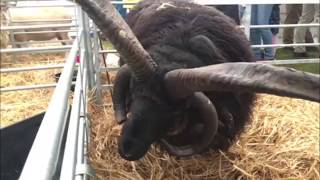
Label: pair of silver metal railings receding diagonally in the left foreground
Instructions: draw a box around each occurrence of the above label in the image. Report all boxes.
[16,1,94,179]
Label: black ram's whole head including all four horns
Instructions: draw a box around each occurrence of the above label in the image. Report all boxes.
[77,0,320,160]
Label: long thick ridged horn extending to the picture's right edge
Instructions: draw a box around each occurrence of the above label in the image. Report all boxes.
[165,63,320,102]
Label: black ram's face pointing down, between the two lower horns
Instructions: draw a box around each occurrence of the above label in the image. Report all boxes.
[118,97,177,160]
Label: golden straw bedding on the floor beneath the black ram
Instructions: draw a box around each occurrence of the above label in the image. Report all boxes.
[90,93,320,180]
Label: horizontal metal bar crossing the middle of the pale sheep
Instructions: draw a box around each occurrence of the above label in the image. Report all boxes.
[0,24,77,31]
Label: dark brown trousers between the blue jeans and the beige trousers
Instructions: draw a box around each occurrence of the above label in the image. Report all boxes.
[283,4,313,44]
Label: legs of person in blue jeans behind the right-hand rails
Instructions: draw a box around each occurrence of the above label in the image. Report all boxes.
[250,4,274,61]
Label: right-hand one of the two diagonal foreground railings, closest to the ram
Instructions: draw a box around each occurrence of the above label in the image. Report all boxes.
[60,38,94,180]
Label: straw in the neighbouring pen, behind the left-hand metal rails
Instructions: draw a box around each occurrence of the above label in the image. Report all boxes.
[0,53,65,127]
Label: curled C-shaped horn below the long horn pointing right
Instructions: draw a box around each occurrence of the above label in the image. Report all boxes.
[161,92,219,157]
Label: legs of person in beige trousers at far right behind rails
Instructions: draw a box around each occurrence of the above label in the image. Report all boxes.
[294,4,320,58]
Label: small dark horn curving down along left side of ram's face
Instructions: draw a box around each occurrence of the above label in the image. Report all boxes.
[112,65,131,124]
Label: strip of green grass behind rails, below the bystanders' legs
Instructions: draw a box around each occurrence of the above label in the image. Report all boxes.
[276,48,320,74]
